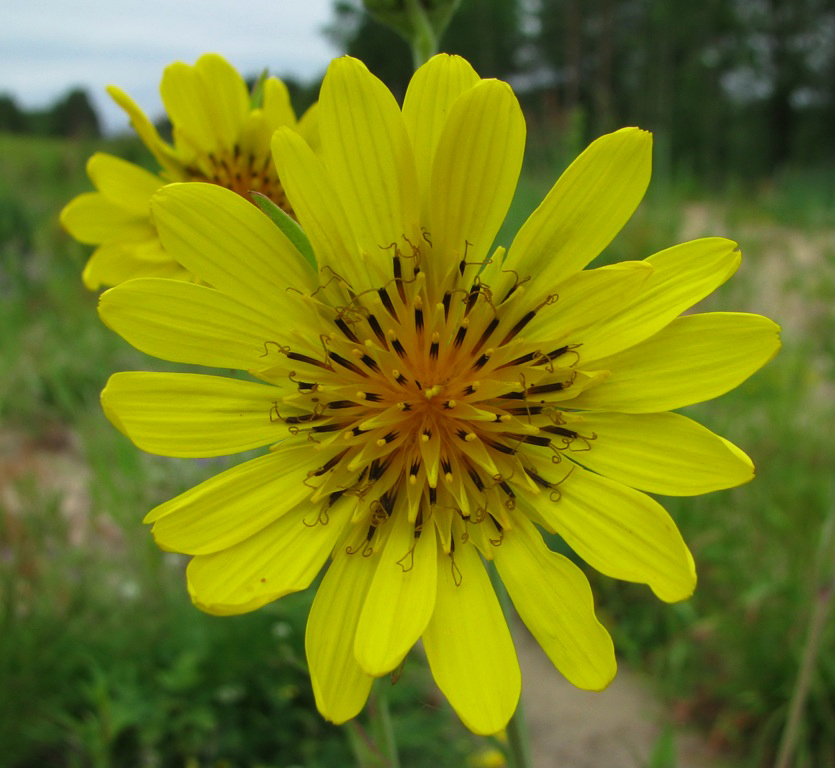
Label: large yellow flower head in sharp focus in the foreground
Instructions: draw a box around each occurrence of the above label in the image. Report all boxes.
[100,56,779,733]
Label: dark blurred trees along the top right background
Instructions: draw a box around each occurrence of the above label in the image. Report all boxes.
[328,0,835,179]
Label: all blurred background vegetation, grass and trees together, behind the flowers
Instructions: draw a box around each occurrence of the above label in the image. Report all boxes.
[0,0,835,768]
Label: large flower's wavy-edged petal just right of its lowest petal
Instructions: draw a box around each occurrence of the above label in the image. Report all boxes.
[493,515,617,691]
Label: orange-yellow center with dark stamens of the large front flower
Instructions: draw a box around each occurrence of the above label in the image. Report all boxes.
[265,243,594,551]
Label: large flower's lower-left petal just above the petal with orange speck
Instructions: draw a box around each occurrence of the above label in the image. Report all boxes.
[145,444,318,555]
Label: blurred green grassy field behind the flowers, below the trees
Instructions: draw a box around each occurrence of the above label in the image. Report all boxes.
[0,136,835,768]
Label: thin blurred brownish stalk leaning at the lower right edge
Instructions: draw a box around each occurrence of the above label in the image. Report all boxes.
[774,506,835,768]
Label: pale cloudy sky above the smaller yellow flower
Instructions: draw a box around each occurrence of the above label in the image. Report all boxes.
[0,0,339,132]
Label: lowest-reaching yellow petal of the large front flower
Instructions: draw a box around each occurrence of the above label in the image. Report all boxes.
[423,543,522,734]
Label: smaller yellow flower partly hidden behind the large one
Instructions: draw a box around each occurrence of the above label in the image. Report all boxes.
[61,53,317,290]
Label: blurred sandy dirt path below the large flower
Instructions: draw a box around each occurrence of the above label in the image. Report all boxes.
[514,627,724,768]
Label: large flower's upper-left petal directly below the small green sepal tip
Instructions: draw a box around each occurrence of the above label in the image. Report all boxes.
[151,182,316,308]
